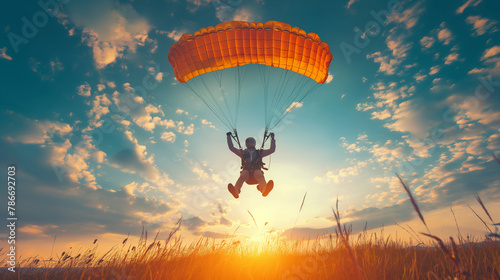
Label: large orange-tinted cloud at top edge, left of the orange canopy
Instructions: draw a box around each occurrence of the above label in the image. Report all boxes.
[66,0,151,69]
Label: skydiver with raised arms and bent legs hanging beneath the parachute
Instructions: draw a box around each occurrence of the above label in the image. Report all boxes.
[226,132,276,198]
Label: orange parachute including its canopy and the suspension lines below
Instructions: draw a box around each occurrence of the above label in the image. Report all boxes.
[168,21,332,148]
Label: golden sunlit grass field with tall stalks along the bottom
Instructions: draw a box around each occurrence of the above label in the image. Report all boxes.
[0,176,500,280]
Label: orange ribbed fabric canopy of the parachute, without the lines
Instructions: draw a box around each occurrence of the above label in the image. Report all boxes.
[168,21,332,84]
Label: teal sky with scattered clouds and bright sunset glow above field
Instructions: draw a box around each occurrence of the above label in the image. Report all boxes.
[0,0,500,255]
